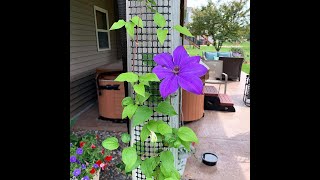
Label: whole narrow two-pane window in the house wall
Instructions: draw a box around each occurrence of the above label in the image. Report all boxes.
[94,6,111,51]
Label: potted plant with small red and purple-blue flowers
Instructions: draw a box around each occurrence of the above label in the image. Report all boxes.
[70,133,112,180]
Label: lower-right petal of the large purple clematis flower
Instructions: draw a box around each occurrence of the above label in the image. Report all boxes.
[178,74,203,95]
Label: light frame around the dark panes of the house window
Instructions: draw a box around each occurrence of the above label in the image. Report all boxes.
[93,6,111,51]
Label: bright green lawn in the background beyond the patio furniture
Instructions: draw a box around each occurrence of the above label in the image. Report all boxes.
[184,42,250,74]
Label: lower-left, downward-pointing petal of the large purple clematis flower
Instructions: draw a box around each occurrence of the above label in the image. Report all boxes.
[160,74,179,99]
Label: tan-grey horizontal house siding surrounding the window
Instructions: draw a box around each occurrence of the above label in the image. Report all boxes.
[70,0,119,117]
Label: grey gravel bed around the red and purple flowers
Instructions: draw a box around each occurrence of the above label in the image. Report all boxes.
[72,129,132,180]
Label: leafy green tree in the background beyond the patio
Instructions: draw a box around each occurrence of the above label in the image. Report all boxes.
[188,0,250,51]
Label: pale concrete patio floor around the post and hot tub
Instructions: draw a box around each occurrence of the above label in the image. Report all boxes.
[73,72,250,180]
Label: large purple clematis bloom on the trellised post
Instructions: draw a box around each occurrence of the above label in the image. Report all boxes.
[152,46,208,98]
